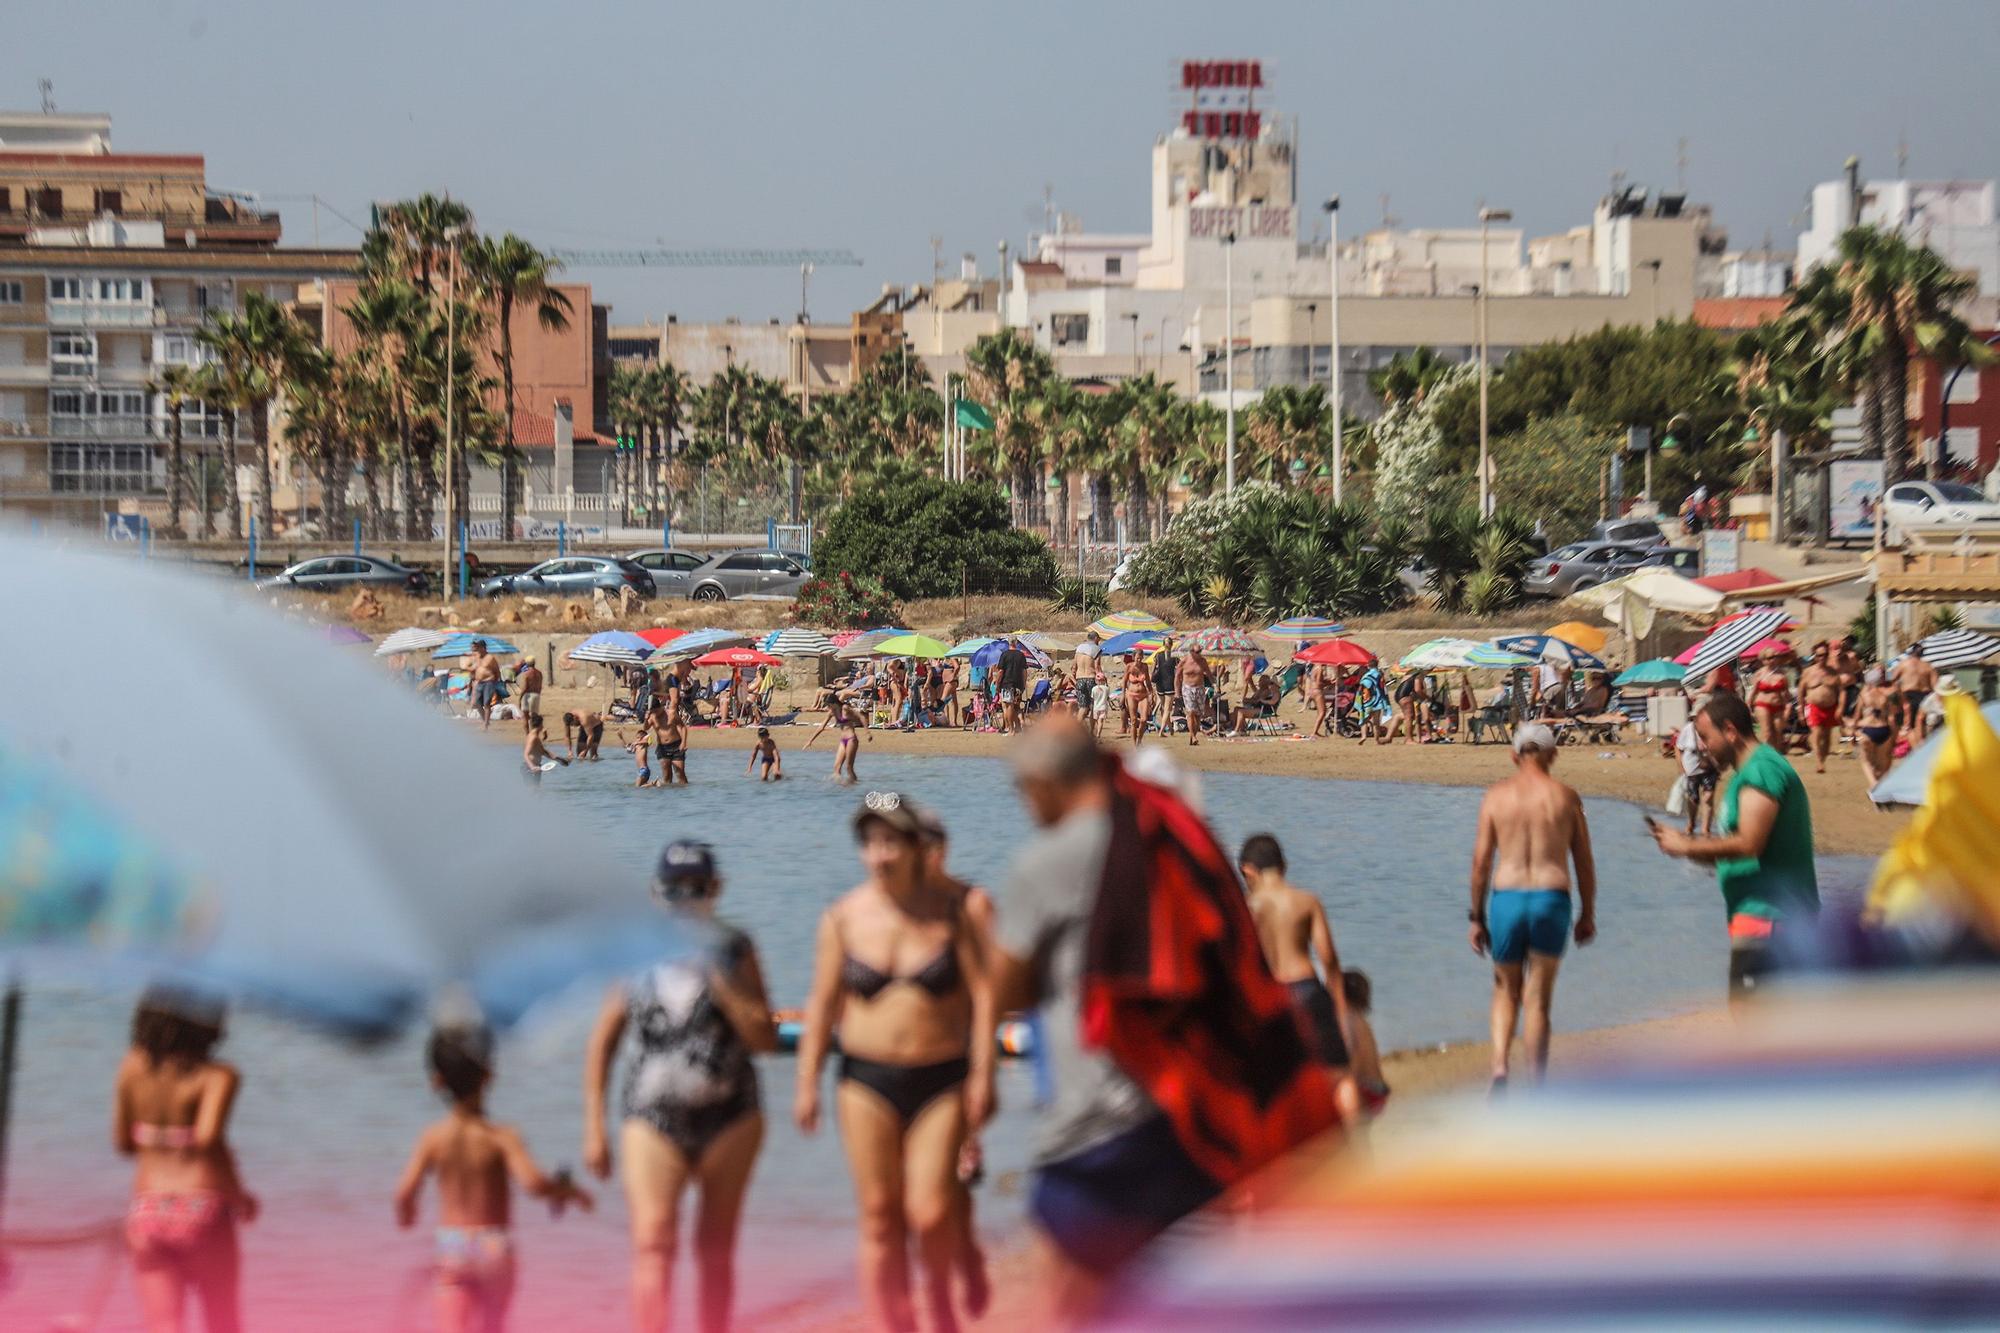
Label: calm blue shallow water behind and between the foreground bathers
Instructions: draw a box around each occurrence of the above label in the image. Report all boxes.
[0,747,1858,1331]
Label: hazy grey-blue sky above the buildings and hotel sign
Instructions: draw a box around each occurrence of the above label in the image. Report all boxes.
[0,0,2000,320]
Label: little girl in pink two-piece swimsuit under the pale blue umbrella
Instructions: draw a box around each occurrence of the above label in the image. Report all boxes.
[112,987,258,1333]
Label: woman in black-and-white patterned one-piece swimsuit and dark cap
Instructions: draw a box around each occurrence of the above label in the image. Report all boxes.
[584,843,778,1331]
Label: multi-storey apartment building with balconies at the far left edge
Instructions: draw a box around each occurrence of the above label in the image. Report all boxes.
[0,112,360,522]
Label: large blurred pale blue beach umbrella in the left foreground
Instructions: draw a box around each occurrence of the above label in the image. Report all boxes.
[0,536,688,1035]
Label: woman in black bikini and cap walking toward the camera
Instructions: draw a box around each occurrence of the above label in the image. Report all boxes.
[794,793,994,1333]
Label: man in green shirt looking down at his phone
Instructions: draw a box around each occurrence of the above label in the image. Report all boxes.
[1648,691,1820,1001]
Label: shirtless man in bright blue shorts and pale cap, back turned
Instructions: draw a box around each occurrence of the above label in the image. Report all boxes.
[1468,723,1598,1089]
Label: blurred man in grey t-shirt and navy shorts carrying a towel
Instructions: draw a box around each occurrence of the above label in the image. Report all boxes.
[996,723,1220,1329]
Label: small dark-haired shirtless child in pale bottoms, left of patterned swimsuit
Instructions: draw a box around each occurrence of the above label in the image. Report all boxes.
[396,1025,594,1333]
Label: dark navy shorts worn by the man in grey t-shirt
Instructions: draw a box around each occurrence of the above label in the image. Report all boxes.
[1028,1115,1222,1273]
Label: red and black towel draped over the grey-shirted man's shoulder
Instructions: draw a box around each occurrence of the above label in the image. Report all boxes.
[1080,755,1338,1187]
